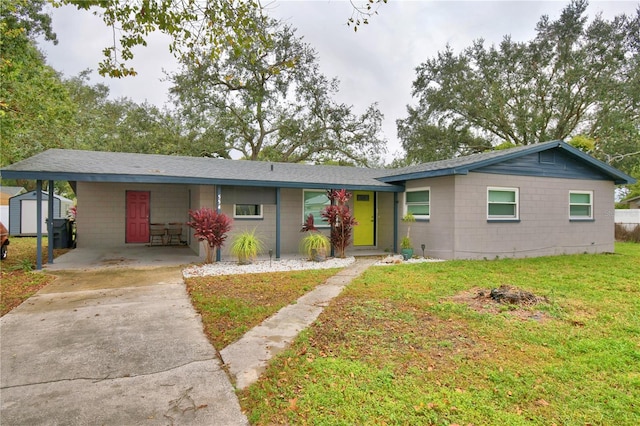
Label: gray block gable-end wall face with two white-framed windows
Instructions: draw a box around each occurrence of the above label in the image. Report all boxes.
[454,173,614,259]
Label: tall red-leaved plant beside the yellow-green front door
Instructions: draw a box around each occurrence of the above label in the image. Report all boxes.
[320,189,358,258]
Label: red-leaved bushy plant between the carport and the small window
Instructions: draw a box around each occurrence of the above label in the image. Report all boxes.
[187,207,233,263]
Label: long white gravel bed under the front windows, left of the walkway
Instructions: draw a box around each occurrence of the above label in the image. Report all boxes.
[182,257,356,278]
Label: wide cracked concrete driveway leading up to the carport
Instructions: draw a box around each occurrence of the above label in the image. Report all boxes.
[0,267,248,426]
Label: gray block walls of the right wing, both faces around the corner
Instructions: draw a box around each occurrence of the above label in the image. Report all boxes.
[399,173,614,259]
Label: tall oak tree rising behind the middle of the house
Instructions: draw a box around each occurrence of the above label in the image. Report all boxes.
[171,17,386,166]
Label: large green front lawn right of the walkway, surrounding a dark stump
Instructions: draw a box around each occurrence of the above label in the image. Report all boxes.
[240,243,640,425]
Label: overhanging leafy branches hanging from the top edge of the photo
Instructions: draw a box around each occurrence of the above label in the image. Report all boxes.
[58,0,387,77]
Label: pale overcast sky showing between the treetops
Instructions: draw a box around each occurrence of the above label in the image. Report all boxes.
[40,0,639,158]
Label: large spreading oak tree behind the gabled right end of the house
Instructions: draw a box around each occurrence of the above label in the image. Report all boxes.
[398,0,640,172]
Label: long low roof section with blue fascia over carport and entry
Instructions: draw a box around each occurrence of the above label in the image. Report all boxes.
[2,149,402,192]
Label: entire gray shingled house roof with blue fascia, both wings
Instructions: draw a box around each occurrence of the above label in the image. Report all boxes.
[2,141,635,192]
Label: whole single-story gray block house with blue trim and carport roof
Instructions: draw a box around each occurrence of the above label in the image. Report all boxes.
[1,141,635,268]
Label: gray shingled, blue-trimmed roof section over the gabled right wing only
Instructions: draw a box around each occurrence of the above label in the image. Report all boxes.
[380,140,635,185]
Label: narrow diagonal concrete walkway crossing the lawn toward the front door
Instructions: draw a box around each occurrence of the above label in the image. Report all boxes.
[220,258,378,389]
